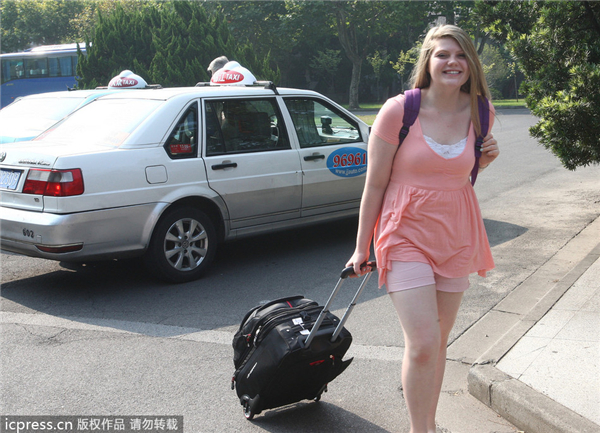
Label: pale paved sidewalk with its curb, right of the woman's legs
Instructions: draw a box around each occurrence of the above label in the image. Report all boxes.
[464,218,600,433]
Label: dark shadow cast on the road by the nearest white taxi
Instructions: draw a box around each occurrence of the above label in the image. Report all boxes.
[2,219,527,336]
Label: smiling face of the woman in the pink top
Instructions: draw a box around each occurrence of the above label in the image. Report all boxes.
[428,38,470,88]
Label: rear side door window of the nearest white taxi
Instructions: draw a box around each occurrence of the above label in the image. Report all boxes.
[205,98,290,156]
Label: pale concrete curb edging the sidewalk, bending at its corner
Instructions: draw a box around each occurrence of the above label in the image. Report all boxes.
[467,240,600,433]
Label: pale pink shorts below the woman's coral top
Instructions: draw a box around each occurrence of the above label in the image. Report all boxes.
[385,261,469,293]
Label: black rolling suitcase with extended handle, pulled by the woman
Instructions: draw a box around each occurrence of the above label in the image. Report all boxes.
[231,262,376,420]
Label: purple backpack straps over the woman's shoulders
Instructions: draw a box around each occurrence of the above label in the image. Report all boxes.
[398,89,490,185]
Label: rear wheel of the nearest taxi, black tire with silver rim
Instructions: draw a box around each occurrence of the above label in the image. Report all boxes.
[145,207,217,283]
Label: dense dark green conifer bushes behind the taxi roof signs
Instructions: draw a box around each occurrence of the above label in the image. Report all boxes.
[77,1,278,88]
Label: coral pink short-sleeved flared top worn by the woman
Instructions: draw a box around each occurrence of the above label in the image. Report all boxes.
[371,95,494,287]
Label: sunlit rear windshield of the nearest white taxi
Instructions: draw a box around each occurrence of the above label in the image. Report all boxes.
[35,99,163,148]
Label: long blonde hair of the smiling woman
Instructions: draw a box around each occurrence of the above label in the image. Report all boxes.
[411,24,491,135]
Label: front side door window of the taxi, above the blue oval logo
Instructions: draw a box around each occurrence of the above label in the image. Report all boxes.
[285,98,362,148]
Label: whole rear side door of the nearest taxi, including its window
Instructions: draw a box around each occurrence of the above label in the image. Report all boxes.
[204,98,302,229]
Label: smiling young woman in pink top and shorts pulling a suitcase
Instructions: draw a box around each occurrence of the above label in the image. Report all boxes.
[347,25,499,433]
